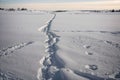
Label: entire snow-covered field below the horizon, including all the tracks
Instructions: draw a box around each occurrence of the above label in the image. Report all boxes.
[0,11,120,80]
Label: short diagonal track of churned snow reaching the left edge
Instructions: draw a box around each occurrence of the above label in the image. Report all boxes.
[0,41,33,57]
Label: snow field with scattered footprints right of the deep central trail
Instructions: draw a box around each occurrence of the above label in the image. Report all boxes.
[51,12,120,80]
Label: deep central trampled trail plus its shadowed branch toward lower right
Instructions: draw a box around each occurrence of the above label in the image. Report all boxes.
[37,14,107,80]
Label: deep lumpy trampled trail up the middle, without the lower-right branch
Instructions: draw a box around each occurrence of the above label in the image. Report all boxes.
[37,14,62,80]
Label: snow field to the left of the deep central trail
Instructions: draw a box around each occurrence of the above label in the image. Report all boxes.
[0,11,51,80]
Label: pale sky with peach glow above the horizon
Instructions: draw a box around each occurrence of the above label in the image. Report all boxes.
[0,0,120,10]
